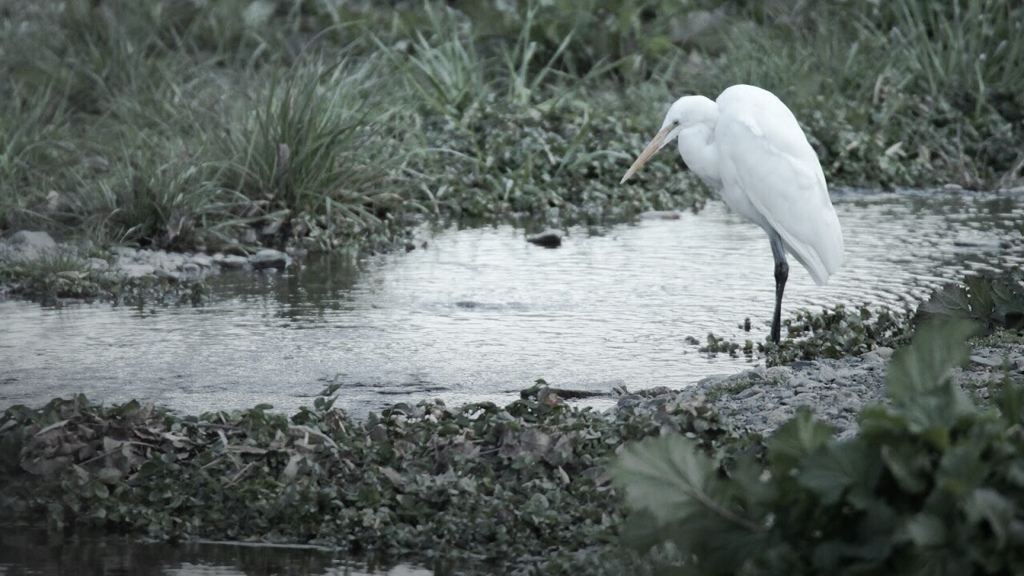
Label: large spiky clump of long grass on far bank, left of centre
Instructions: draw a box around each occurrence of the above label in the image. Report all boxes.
[218,54,406,249]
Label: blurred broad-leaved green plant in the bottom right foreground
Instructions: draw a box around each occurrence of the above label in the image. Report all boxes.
[615,320,1024,574]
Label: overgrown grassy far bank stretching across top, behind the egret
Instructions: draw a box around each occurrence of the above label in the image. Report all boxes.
[0,0,1024,251]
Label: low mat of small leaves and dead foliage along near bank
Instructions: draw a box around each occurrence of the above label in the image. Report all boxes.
[0,384,734,571]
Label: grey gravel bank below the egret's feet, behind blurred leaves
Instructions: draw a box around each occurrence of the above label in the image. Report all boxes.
[611,344,1024,438]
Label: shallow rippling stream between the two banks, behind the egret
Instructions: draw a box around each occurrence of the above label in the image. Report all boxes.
[0,192,1024,415]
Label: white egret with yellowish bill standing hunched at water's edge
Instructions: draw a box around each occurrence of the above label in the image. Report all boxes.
[622,84,844,343]
